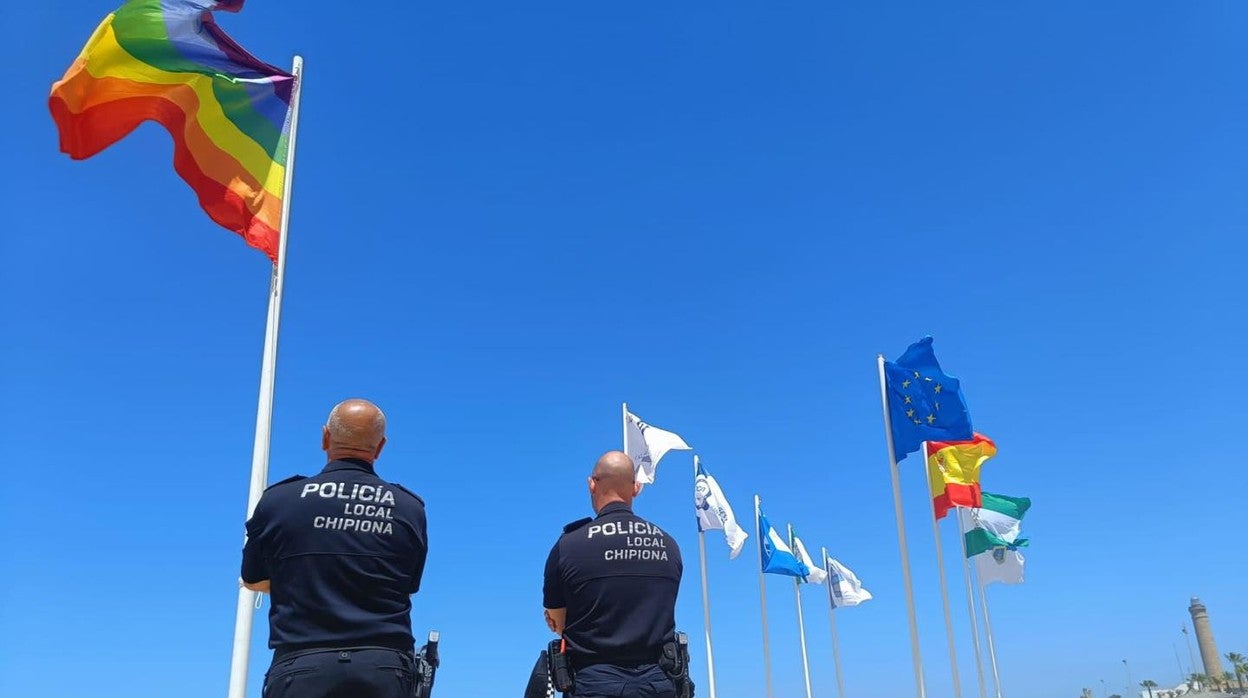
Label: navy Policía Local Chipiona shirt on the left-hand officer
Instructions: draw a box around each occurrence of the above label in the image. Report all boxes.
[242,458,429,652]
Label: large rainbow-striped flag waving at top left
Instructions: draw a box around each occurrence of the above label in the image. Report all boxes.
[47,0,295,260]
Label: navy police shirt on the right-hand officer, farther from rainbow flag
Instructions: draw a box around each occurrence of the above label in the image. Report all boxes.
[543,502,684,667]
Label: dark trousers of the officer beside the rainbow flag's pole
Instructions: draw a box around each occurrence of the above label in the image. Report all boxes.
[263,648,416,698]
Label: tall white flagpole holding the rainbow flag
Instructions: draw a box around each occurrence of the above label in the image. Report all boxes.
[228,56,303,698]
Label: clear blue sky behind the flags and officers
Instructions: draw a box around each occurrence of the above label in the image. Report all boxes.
[0,0,1248,698]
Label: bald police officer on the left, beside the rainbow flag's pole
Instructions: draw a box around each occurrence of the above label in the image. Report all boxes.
[242,400,428,698]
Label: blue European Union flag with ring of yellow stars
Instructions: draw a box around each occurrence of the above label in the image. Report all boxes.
[884,337,975,461]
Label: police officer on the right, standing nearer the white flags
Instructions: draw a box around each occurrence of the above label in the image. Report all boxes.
[543,451,684,698]
